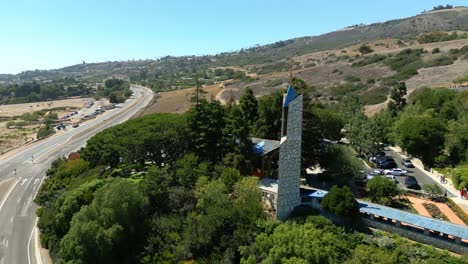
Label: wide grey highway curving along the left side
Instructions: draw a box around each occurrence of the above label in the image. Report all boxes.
[0,86,153,264]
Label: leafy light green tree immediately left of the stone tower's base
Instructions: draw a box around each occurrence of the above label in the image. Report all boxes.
[183,177,263,262]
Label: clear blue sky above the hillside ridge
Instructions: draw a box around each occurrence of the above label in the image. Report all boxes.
[0,0,468,73]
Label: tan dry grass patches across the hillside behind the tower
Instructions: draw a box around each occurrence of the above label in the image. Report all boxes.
[138,35,468,115]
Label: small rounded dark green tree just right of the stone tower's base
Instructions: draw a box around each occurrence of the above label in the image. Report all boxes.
[321,186,359,216]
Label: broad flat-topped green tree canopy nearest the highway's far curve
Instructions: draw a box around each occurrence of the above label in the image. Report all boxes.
[82,114,188,167]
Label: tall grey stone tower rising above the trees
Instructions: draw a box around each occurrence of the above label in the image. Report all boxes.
[276,95,303,221]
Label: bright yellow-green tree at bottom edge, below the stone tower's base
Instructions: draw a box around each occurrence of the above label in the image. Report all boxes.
[241,216,355,264]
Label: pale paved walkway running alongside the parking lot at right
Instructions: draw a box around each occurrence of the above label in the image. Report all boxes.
[389,147,468,214]
